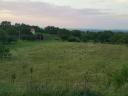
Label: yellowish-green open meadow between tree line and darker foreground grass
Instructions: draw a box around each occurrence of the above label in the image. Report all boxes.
[0,41,128,96]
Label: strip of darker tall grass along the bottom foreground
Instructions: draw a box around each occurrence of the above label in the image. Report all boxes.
[0,83,102,96]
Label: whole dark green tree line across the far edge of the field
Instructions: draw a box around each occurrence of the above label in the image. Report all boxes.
[0,21,128,44]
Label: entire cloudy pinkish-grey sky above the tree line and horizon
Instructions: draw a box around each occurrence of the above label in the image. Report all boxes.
[0,0,128,30]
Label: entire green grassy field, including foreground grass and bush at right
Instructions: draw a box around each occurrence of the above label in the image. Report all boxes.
[0,41,128,96]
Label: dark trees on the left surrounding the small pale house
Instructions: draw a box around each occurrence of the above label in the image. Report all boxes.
[0,21,42,42]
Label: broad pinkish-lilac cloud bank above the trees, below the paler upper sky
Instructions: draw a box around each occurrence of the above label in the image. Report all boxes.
[0,1,128,29]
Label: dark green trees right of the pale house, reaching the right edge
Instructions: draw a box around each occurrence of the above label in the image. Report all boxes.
[44,26,128,44]
